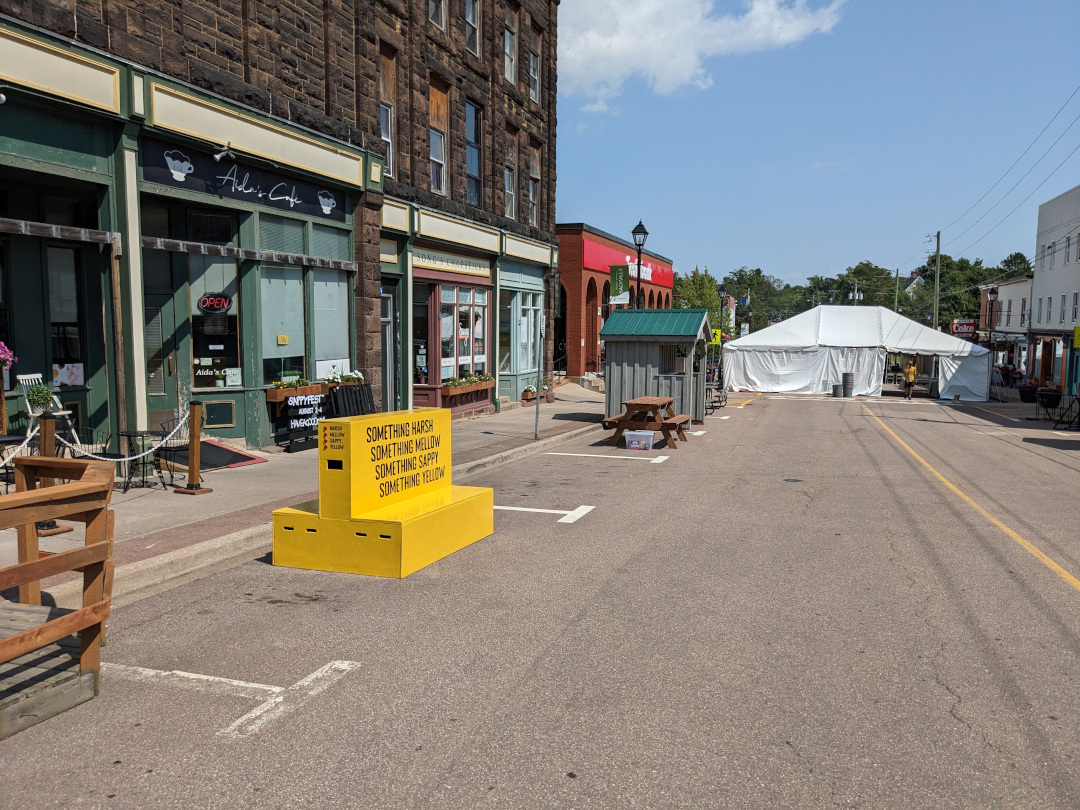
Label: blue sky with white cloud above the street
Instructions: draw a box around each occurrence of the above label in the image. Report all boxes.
[556,0,1080,284]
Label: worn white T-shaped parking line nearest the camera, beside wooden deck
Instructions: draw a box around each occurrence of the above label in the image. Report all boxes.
[102,661,360,739]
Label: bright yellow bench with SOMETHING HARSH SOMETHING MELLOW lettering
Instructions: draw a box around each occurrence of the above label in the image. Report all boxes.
[273,408,495,578]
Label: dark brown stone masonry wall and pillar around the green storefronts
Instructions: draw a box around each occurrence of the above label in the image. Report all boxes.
[6,0,558,401]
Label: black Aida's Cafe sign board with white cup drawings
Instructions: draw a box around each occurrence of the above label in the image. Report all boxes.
[139,138,348,222]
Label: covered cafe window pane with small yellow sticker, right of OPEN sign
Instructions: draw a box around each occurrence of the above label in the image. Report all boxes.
[259,266,306,386]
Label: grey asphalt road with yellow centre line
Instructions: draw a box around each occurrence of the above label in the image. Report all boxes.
[0,396,1080,808]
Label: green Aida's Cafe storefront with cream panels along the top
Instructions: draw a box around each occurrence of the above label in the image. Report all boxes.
[0,24,382,446]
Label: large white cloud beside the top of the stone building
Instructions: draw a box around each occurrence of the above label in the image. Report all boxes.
[558,0,846,106]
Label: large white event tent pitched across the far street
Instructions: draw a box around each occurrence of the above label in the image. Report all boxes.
[724,305,990,402]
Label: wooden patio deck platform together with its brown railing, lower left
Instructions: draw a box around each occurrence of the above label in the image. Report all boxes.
[0,456,116,739]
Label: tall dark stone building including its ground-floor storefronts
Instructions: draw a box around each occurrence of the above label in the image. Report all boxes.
[0,0,557,445]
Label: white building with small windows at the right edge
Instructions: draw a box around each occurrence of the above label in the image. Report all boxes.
[1028,186,1080,393]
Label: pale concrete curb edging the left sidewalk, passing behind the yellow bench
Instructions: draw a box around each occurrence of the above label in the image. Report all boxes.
[48,422,603,608]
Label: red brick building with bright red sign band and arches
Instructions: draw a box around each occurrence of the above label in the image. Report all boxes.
[555,222,674,377]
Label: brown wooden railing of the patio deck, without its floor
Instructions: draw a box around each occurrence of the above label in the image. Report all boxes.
[0,456,114,694]
